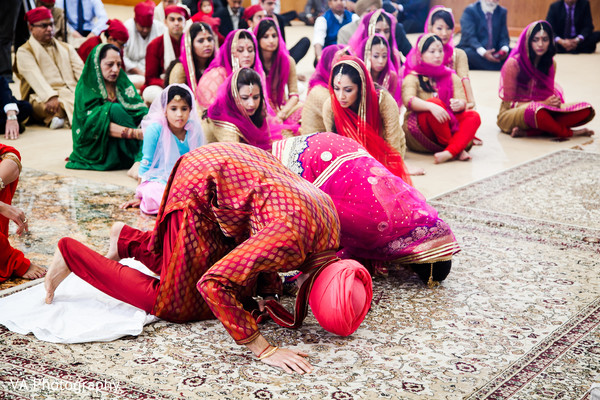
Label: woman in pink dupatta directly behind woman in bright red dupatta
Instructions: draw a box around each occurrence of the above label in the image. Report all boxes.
[358,34,402,107]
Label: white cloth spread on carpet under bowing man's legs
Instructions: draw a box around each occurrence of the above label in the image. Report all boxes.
[0,258,158,343]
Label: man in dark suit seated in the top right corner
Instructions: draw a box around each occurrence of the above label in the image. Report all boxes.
[546,0,600,54]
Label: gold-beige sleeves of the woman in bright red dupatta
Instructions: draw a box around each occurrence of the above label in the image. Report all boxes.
[323,90,406,158]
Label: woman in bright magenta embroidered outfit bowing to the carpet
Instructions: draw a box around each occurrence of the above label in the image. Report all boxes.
[273,132,460,285]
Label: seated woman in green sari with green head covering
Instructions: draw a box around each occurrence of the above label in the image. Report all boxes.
[66,44,148,171]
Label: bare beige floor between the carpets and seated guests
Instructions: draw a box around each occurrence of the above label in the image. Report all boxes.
[0,5,600,198]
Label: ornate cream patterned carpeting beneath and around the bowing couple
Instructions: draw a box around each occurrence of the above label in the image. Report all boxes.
[0,150,600,400]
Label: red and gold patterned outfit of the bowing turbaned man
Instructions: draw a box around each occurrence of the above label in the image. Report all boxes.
[59,143,339,344]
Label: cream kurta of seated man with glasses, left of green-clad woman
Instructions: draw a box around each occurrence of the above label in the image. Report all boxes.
[14,37,83,122]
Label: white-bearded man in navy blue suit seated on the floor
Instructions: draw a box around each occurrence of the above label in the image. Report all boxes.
[457,0,510,71]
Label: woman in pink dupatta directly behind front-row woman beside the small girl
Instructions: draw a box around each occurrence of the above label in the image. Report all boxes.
[196,29,265,112]
